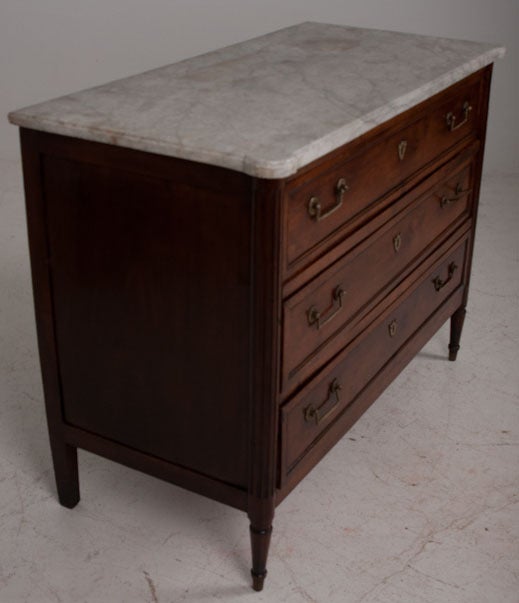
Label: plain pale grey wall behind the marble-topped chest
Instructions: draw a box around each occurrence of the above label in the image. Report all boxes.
[0,0,519,171]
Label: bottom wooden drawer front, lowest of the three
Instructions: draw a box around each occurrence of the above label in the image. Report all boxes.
[281,239,468,476]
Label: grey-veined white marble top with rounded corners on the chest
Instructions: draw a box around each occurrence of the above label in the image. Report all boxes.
[9,23,504,178]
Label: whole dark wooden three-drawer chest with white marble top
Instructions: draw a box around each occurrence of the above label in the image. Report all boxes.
[10,23,502,590]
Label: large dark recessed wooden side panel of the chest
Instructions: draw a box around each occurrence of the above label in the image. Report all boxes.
[33,135,251,489]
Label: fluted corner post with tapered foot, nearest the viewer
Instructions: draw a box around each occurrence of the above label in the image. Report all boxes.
[247,180,282,591]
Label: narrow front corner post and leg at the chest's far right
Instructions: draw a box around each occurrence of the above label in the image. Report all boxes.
[449,65,493,361]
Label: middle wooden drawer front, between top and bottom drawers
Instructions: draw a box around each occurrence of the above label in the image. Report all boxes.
[282,158,473,391]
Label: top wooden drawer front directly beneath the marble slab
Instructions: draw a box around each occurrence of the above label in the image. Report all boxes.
[285,73,483,272]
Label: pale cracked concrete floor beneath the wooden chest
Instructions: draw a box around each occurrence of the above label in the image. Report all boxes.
[0,162,519,603]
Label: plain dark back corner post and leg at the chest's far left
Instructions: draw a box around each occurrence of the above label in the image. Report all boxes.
[20,128,79,508]
